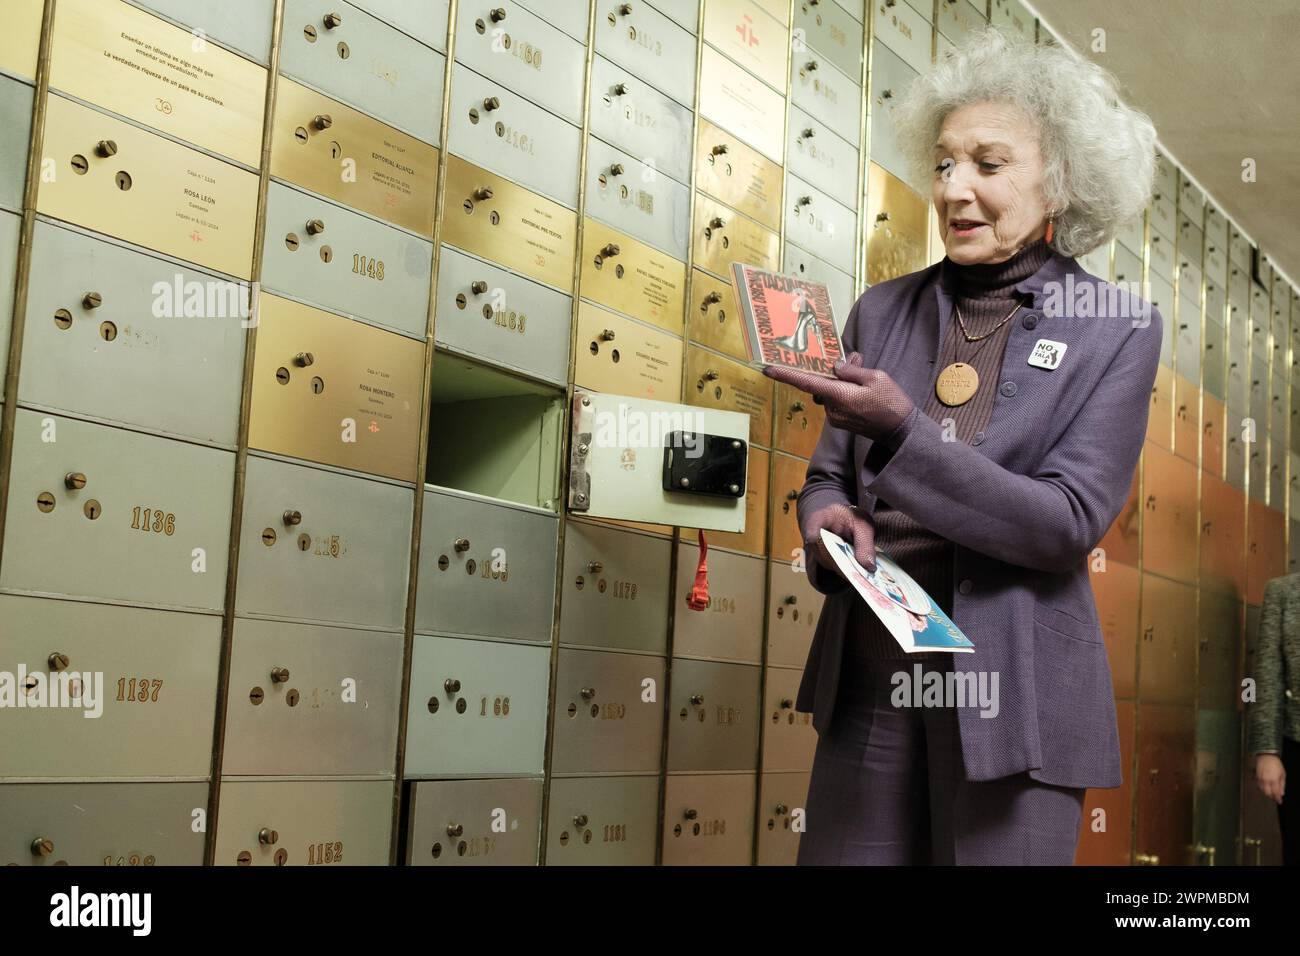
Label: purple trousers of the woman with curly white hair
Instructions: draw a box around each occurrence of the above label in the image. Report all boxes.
[797,641,1086,866]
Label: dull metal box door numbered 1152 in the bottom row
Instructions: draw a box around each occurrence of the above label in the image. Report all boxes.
[216,779,393,866]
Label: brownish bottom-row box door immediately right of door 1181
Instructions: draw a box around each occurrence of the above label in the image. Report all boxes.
[662,774,758,866]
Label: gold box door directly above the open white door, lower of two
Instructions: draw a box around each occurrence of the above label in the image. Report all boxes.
[573,302,681,402]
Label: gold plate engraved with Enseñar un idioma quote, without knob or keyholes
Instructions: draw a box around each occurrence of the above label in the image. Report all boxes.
[49,0,267,168]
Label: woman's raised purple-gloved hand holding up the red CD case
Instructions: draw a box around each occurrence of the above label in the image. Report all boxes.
[763,352,915,441]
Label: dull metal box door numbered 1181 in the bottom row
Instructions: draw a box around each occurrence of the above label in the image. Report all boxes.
[546,775,659,866]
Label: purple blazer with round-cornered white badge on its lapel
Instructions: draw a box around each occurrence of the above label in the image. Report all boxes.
[796,254,1162,787]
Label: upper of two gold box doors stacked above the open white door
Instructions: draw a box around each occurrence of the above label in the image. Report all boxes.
[579,217,686,335]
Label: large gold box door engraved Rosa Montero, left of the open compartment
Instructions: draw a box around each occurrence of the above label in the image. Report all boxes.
[248,294,424,481]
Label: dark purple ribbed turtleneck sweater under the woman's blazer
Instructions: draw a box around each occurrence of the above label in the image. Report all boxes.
[841,239,1052,660]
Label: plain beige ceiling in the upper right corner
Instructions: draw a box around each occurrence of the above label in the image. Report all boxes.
[1027,0,1300,291]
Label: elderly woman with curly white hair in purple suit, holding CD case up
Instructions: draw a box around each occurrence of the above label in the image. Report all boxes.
[766,31,1161,864]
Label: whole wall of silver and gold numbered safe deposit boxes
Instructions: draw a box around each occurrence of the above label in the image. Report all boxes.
[0,0,1300,866]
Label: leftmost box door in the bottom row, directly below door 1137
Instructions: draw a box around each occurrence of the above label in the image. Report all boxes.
[0,780,208,866]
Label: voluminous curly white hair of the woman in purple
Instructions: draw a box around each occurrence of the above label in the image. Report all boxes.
[894,27,1156,256]
